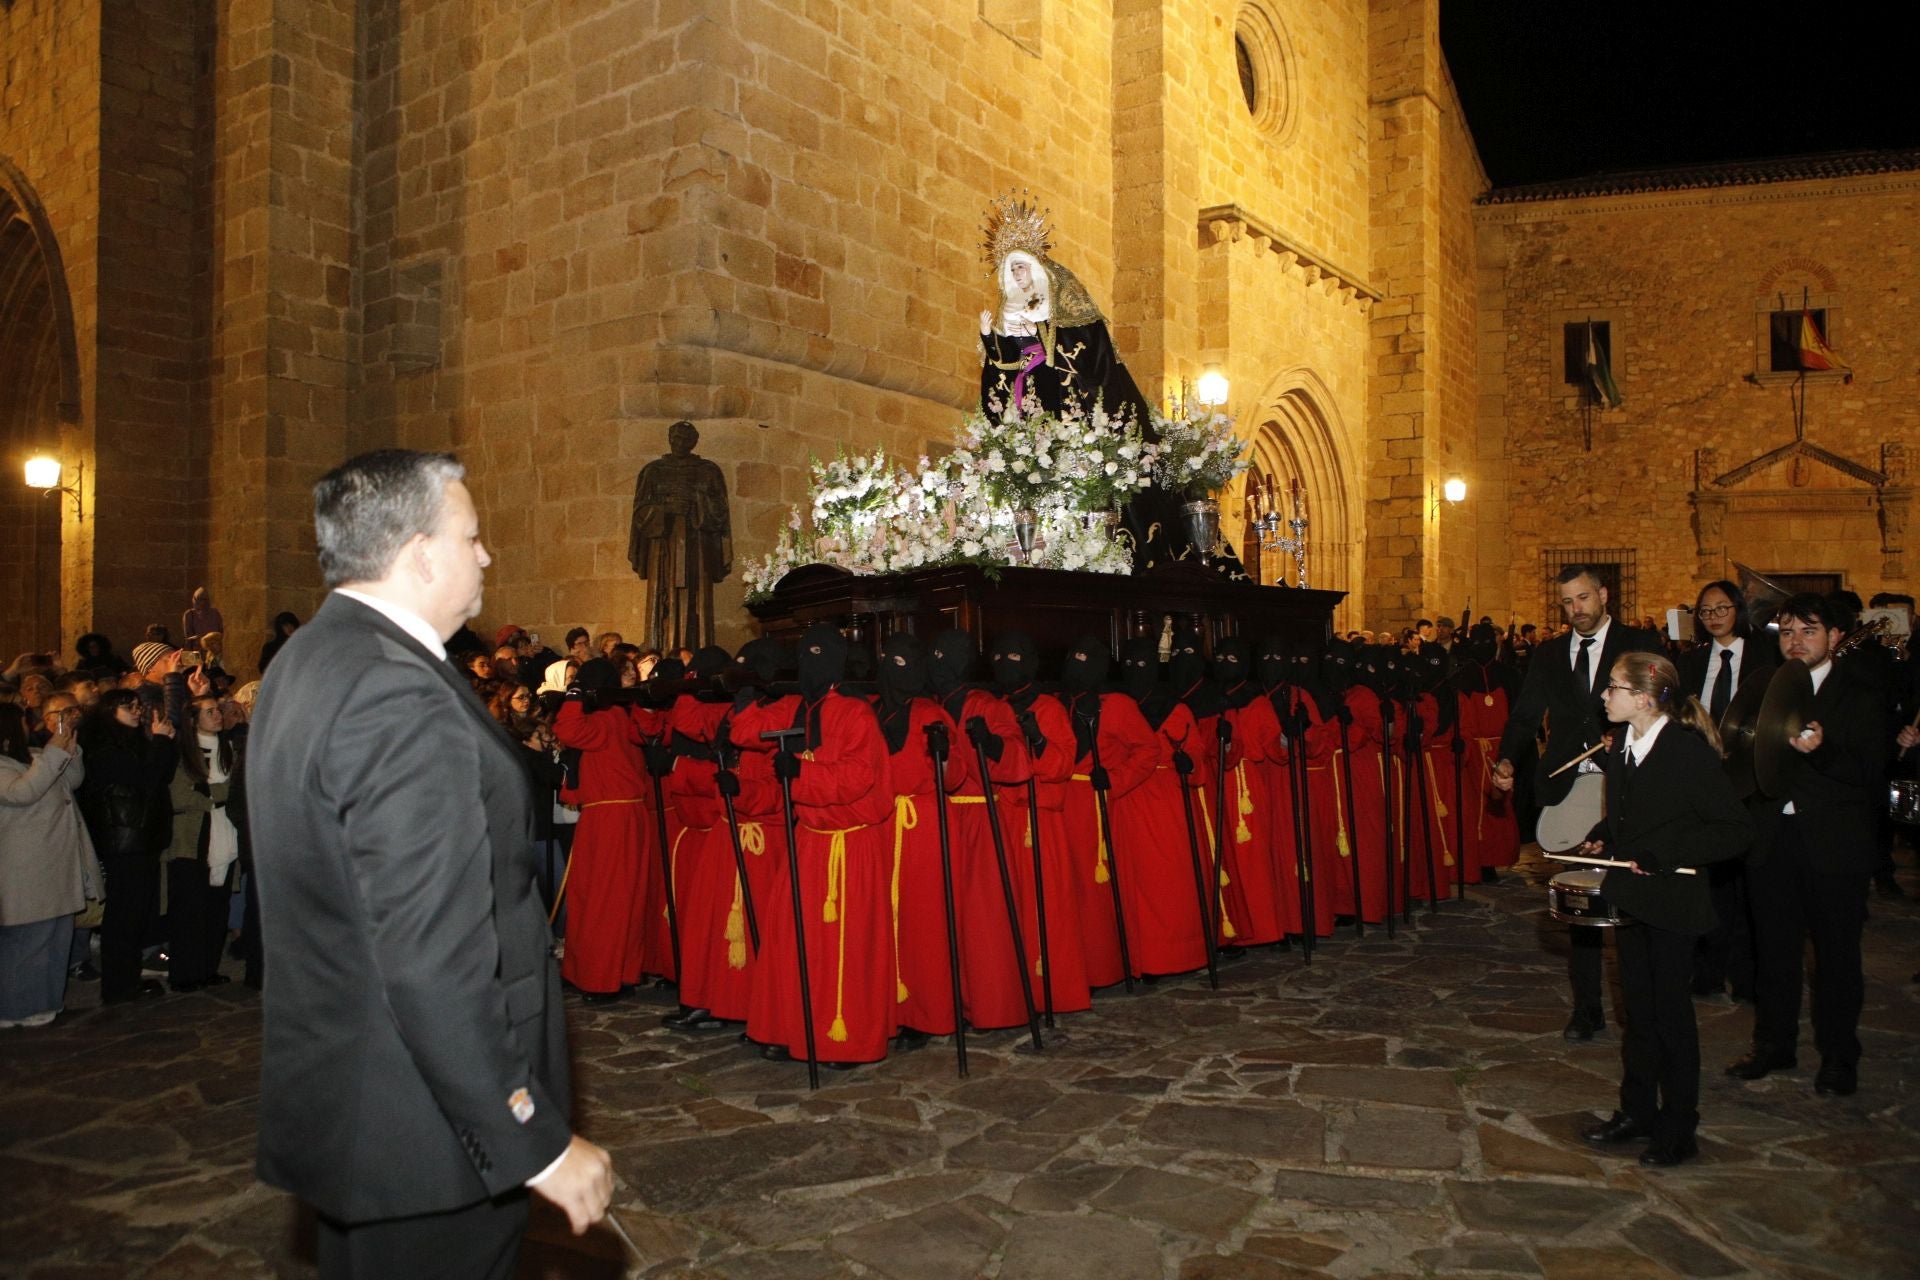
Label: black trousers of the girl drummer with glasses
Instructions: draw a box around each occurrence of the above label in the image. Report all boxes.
[1613,925,1699,1142]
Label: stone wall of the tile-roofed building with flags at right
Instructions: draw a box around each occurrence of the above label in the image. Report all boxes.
[1476,173,1920,622]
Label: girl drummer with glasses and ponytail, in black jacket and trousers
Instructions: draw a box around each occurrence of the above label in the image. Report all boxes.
[1580,652,1753,1169]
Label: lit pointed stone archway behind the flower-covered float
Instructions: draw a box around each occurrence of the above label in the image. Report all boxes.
[1231,368,1361,629]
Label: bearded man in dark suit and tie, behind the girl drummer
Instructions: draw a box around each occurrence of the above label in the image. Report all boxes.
[1494,564,1661,1040]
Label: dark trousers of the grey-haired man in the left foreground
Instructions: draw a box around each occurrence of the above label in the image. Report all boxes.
[317,1192,528,1280]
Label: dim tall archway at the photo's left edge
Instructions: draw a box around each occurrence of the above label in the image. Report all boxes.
[0,155,81,658]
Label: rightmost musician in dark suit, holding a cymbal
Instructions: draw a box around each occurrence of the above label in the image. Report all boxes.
[1726,595,1893,1098]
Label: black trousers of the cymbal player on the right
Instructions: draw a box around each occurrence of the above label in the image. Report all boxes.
[1747,816,1872,1067]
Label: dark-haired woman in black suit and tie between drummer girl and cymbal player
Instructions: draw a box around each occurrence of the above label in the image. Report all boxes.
[1674,580,1780,1000]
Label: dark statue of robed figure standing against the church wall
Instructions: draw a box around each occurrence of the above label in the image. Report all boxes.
[626,422,733,652]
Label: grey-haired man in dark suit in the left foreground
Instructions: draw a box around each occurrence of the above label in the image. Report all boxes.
[248,449,612,1280]
